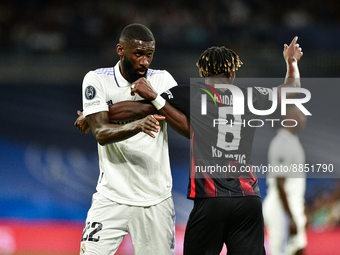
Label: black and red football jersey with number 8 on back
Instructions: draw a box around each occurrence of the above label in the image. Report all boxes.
[162,83,272,199]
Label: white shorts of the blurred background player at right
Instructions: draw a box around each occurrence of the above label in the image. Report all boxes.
[263,196,307,255]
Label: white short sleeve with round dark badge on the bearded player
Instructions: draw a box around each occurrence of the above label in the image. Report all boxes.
[82,71,109,117]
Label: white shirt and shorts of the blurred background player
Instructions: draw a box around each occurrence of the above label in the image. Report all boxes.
[263,128,307,255]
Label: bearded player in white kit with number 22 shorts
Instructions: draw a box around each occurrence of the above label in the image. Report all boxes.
[80,24,177,255]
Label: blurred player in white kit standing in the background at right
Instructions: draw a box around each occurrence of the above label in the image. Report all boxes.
[263,105,307,255]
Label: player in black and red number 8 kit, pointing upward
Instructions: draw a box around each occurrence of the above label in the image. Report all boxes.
[76,37,302,255]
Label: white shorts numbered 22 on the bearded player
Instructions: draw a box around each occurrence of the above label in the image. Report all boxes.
[80,192,175,255]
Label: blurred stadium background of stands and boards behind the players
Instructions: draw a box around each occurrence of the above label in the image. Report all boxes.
[0,0,340,255]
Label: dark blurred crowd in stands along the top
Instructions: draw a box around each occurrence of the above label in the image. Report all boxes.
[0,0,340,52]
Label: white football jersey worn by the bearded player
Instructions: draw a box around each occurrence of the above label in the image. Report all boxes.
[83,62,177,206]
